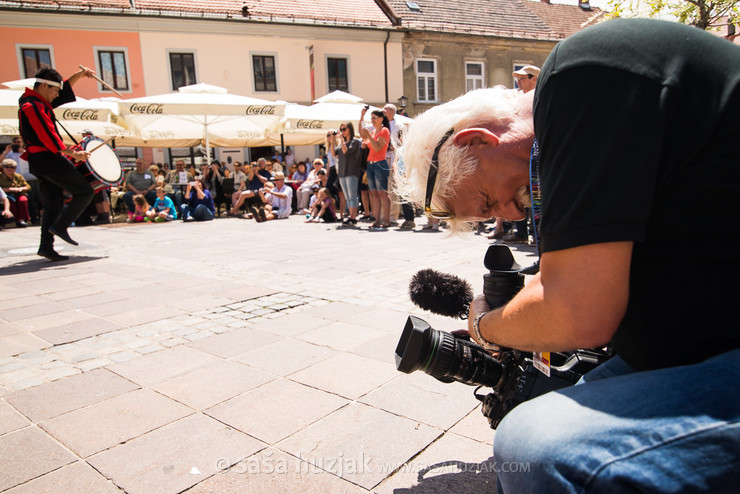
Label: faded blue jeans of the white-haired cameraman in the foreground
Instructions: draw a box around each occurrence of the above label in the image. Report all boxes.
[494,350,740,494]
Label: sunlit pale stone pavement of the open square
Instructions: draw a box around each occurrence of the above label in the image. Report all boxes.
[0,216,534,494]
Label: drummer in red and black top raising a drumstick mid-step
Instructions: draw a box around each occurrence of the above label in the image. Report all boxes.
[18,67,95,261]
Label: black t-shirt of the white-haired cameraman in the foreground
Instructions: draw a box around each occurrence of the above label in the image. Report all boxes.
[534,19,740,370]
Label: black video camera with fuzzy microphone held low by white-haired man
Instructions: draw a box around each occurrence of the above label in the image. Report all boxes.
[395,244,612,429]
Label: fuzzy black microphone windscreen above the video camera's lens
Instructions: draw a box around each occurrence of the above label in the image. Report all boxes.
[409,269,473,319]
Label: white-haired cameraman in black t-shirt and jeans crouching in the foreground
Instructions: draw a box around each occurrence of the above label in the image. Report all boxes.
[396,19,740,493]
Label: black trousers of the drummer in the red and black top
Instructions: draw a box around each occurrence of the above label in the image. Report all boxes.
[28,152,95,250]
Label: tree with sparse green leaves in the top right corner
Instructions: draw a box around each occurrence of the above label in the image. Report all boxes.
[607,0,740,29]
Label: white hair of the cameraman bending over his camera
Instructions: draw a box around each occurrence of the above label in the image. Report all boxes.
[395,86,521,218]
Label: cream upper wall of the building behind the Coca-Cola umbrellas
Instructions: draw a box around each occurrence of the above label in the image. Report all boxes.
[140,17,403,104]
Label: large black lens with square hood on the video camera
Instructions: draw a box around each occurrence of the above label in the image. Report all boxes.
[396,316,503,387]
